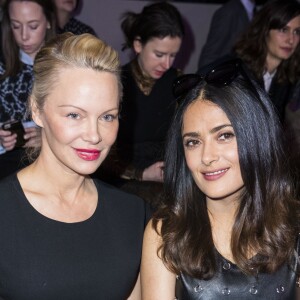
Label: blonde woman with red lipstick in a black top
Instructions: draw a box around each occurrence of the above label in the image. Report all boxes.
[0,33,147,300]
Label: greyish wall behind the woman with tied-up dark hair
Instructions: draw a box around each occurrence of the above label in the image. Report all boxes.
[76,0,219,73]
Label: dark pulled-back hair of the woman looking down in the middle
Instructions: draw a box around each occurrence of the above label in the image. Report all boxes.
[121,2,184,49]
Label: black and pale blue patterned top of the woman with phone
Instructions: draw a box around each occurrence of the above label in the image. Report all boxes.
[0,61,33,123]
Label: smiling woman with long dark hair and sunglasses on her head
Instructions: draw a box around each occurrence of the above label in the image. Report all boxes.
[141,61,299,300]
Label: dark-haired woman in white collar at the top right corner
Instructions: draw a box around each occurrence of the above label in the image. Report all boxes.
[234,0,300,121]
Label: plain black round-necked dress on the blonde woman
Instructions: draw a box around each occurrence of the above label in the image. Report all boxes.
[0,175,149,300]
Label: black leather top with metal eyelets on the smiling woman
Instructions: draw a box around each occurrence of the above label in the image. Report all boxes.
[176,245,299,300]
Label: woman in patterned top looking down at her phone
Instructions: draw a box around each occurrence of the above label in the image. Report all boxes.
[0,0,55,178]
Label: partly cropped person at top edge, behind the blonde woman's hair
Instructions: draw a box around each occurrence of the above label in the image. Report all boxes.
[53,0,96,35]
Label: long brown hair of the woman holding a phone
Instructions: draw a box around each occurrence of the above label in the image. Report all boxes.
[0,0,55,79]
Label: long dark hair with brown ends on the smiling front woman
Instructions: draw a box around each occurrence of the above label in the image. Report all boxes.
[153,76,299,279]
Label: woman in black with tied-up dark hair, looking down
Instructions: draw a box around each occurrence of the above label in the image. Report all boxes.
[102,2,184,206]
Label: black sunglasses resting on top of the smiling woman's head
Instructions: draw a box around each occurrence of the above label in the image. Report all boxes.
[173,59,246,99]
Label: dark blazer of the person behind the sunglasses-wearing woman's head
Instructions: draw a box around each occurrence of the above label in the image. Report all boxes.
[198,0,250,69]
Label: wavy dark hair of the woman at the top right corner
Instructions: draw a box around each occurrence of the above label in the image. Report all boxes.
[234,0,300,83]
